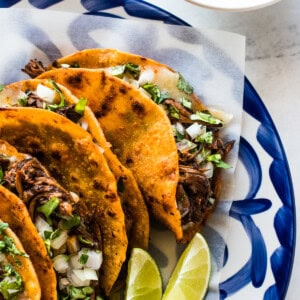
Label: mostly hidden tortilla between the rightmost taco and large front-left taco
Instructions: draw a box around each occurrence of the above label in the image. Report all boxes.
[0,79,149,250]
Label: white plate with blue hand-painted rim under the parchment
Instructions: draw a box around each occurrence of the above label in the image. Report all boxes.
[0,0,296,300]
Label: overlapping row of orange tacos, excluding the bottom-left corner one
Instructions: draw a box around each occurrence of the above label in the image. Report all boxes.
[0,49,233,299]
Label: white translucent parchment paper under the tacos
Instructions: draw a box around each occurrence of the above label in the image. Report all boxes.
[0,9,245,299]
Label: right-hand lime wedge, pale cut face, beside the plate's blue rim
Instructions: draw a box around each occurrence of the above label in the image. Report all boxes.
[162,233,211,300]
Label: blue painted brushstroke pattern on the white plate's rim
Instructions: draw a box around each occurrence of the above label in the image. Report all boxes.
[0,0,296,300]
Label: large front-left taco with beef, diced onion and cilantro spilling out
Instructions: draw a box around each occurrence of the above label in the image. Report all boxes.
[0,107,127,299]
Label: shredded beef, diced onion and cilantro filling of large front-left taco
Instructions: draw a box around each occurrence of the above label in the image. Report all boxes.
[0,142,102,299]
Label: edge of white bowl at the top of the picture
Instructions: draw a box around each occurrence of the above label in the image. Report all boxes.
[186,0,280,11]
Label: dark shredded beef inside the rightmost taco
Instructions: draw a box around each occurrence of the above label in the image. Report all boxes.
[164,99,234,226]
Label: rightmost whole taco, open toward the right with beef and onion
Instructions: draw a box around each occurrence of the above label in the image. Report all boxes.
[25,49,233,243]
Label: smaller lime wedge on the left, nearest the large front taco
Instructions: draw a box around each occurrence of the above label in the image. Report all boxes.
[125,248,162,300]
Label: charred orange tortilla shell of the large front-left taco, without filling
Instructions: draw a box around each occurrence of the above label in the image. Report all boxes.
[0,108,127,294]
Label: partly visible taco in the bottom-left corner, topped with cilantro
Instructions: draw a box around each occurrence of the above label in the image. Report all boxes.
[0,211,41,300]
